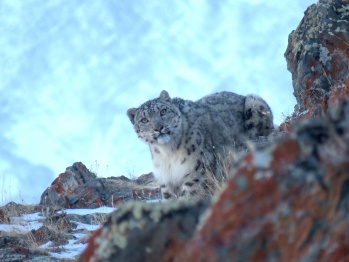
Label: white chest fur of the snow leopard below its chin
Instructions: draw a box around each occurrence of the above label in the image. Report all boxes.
[151,146,196,185]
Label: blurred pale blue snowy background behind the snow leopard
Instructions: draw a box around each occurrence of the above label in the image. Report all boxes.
[0,0,316,204]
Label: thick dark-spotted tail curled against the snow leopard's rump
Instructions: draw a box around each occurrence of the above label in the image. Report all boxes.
[244,95,274,139]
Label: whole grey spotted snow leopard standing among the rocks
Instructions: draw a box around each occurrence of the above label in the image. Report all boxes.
[127,90,274,201]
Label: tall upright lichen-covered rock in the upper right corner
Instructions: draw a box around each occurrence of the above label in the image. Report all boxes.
[285,0,349,119]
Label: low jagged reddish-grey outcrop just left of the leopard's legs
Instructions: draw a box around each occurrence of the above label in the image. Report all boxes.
[40,162,159,211]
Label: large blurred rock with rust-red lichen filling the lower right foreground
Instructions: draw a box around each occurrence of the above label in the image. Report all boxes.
[174,99,349,261]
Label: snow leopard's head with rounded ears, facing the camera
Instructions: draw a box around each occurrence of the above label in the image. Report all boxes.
[127,90,182,144]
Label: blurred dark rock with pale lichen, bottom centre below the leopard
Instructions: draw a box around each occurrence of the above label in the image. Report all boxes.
[81,202,207,262]
